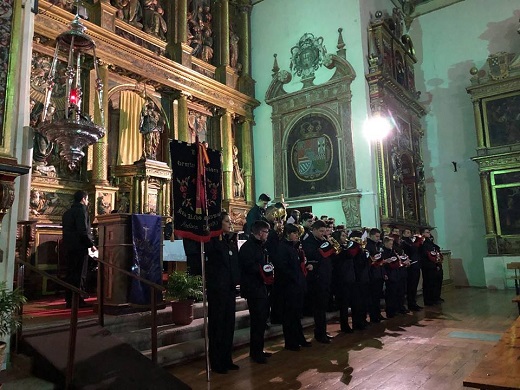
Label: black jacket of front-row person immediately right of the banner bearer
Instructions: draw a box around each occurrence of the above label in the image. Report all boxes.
[238,235,267,299]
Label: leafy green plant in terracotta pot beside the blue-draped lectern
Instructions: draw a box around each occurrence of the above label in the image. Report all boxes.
[166,271,202,325]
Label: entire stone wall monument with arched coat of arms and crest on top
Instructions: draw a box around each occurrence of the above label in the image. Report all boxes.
[266,29,361,228]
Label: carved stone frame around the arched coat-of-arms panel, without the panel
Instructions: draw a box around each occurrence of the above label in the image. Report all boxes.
[266,35,361,226]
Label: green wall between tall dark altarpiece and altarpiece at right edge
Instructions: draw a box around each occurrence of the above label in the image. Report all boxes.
[410,0,520,286]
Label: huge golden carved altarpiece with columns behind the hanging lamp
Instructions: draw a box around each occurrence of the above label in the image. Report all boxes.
[18,0,259,295]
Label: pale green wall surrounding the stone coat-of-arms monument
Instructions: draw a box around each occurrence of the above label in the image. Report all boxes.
[251,0,391,226]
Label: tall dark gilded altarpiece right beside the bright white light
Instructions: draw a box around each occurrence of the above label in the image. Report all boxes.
[365,8,428,230]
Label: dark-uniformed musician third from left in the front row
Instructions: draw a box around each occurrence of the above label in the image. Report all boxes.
[273,223,311,351]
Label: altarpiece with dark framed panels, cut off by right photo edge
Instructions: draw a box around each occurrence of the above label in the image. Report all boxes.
[467,52,520,255]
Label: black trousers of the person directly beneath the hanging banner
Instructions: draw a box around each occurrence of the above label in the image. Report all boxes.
[208,289,236,370]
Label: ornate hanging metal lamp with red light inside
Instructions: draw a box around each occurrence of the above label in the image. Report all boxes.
[37,15,105,169]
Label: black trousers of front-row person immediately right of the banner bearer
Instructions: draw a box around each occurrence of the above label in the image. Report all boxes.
[247,296,269,359]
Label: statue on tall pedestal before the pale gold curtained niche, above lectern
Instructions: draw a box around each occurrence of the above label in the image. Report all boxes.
[139,100,164,160]
